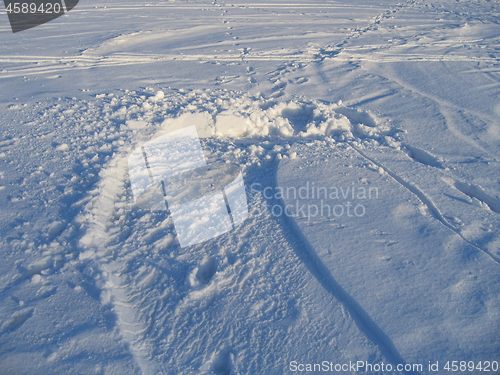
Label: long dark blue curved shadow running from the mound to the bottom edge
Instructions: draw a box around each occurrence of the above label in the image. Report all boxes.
[267,163,419,375]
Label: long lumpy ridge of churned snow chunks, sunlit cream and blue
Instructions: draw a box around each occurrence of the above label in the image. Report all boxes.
[56,89,398,147]
